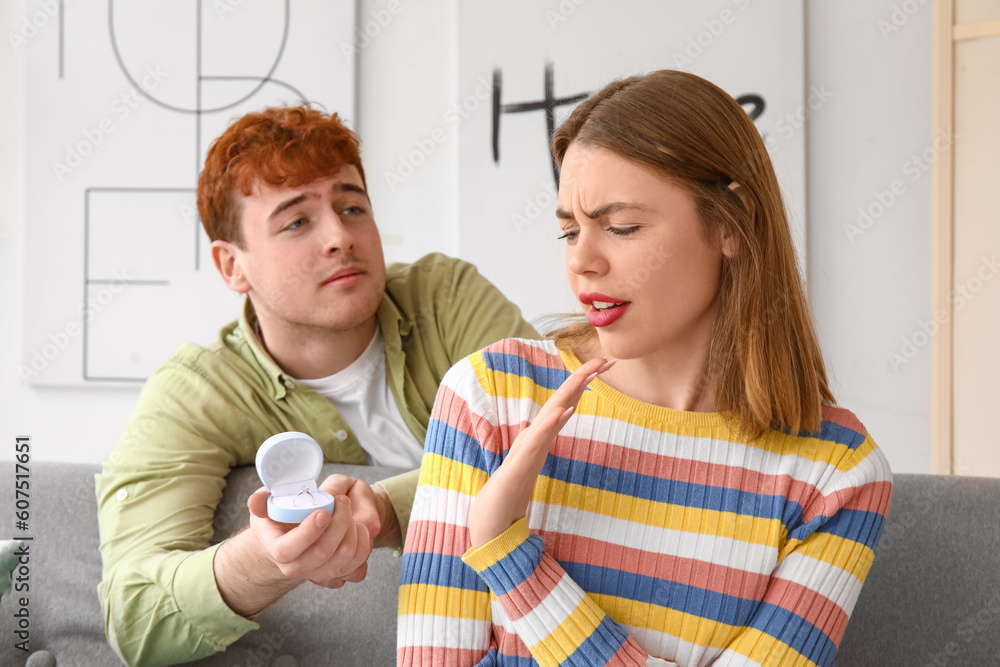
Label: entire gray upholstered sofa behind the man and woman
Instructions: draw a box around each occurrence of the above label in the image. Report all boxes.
[0,462,1000,667]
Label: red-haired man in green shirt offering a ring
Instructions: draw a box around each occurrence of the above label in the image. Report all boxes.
[97,106,537,664]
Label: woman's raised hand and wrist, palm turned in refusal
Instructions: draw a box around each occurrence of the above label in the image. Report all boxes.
[469,357,615,549]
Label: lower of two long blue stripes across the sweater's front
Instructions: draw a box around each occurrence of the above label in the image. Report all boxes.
[559,560,760,626]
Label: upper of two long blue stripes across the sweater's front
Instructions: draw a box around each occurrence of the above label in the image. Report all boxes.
[541,454,802,525]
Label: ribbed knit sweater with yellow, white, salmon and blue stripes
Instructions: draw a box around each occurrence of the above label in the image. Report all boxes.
[397,339,892,667]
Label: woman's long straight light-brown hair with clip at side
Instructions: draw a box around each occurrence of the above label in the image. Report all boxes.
[549,70,834,439]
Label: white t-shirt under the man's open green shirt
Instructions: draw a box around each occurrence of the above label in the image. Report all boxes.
[296,328,424,468]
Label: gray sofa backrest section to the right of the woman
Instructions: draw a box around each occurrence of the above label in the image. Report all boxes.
[837,475,1000,667]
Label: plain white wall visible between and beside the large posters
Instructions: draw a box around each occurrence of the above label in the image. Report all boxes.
[0,0,931,472]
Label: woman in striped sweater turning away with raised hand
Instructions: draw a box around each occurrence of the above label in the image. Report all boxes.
[398,71,892,667]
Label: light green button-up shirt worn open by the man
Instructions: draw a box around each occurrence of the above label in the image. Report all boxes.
[97,254,537,664]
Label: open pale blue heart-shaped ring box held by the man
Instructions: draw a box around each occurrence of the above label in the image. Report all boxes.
[256,431,333,523]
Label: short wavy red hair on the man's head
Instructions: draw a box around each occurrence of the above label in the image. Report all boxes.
[198,104,365,248]
